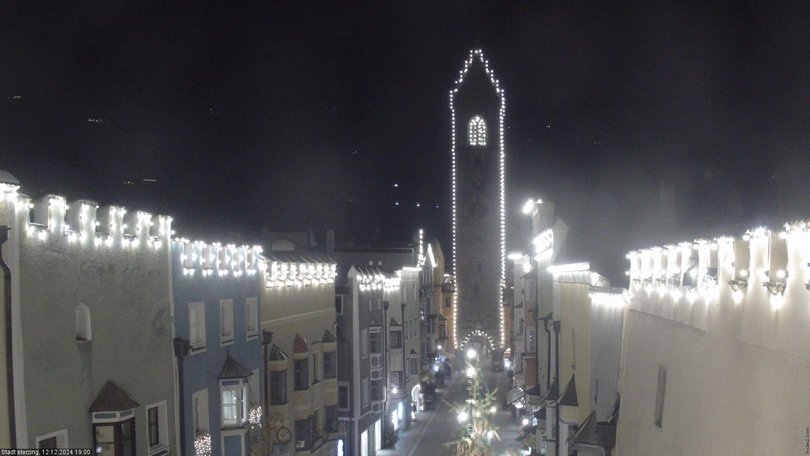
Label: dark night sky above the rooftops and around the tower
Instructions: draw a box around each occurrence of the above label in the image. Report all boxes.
[0,1,810,283]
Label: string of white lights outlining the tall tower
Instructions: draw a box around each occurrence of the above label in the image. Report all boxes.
[450,49,506,346]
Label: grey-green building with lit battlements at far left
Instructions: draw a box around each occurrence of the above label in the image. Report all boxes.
[0,173,178,456]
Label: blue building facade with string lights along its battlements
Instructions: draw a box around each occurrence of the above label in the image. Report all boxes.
[171,239,264,456]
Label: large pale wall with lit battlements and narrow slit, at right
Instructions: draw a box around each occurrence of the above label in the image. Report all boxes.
[617,222,810,455]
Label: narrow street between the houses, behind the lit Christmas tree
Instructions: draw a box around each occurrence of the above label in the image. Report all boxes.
[377,364,520,456]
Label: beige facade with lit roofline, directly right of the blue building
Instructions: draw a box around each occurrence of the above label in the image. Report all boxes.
[261,252,334,456]
